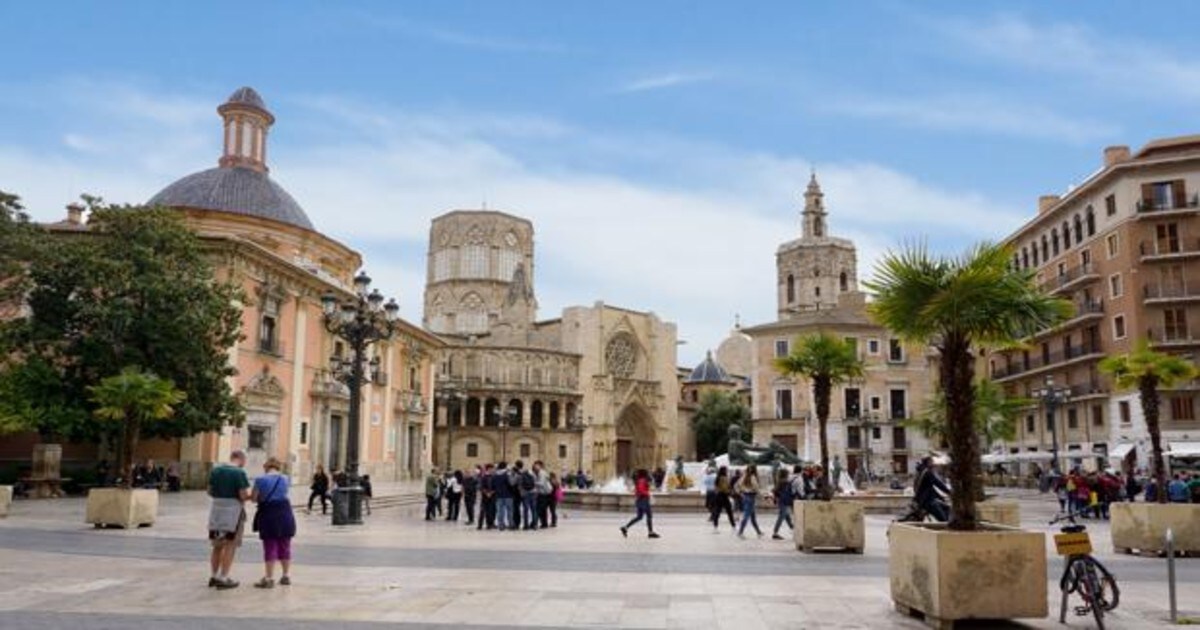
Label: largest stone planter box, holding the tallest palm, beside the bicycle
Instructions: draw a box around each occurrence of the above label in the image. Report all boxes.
[888,523,1049,629]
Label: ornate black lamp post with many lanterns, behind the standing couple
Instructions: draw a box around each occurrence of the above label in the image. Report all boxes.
[320,271,400,526]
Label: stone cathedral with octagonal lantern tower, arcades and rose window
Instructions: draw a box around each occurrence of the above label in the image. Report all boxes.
[424,210,679,479]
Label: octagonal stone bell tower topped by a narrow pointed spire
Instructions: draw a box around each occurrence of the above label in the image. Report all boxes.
[775,173,858,319]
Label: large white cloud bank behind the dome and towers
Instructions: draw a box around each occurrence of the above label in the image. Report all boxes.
[0,81,1022,365]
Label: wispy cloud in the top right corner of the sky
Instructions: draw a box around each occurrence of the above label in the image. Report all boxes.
[932,14,1200,98]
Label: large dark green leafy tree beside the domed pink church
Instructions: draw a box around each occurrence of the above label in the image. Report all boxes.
[11,197,244,440]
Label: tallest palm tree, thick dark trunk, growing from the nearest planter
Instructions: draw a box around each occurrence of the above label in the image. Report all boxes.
[866,244,1072,530]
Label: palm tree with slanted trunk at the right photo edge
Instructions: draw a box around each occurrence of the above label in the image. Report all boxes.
[1100,341,1196,503]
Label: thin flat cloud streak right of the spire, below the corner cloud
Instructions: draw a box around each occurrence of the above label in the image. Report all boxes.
[827,95,1120,143]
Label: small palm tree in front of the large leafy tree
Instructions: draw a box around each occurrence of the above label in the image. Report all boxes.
[88,367,187,488]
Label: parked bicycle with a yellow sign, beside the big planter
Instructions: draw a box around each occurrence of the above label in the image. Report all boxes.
[1050,506,1121,630]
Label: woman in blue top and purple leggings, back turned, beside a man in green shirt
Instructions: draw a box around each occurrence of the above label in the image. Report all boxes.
[250,457,296,588]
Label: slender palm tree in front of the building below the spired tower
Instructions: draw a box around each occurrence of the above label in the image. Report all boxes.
[775,332,863,500]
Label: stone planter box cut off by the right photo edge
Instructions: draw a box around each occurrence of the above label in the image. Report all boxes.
[1109,503,1200,554]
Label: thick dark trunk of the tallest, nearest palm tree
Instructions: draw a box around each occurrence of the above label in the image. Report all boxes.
[938,334,979,532]
